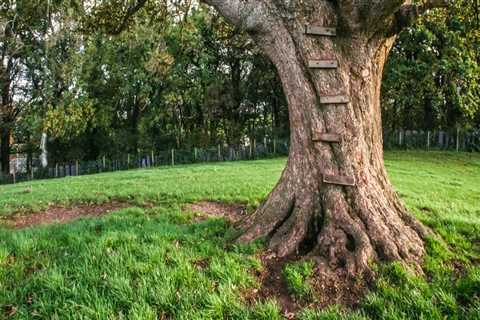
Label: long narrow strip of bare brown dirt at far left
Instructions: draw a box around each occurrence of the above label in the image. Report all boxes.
[4,201,129,229]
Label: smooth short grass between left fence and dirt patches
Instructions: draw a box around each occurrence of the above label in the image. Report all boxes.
[0,159,285,215]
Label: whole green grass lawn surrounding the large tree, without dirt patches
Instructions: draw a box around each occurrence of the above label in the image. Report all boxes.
[0,152,480,320]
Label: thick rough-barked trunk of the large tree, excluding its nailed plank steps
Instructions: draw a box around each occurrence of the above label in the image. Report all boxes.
[205,0,450,276]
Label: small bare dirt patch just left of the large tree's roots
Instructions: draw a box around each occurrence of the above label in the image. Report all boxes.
[183,201,247,223]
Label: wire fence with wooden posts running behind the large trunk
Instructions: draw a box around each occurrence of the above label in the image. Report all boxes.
[0,130,480,184]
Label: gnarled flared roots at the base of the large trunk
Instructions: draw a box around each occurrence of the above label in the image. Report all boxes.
[239,170,428,278]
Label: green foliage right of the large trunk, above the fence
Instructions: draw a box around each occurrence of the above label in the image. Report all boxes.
[382,0,480,130]
